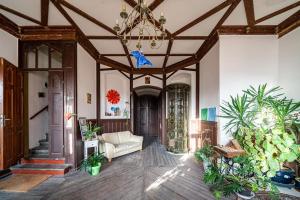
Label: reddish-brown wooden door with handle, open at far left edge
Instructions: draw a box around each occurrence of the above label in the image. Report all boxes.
[0,58,23,170]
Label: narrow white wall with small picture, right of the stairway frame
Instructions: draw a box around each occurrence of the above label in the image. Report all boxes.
[77,45,97,119]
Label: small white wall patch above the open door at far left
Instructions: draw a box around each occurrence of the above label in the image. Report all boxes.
[0,29,18,66]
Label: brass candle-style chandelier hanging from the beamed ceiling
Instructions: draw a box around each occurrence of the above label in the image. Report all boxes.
[113,0,167,51]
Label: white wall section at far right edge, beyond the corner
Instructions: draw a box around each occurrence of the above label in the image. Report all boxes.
[279,28,300,101]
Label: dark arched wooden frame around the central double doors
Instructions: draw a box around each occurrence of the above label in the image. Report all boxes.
[130,85,163,144]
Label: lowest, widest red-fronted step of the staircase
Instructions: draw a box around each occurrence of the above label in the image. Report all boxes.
[10,163,71,175]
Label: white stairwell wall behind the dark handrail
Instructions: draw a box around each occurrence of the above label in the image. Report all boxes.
[28,72,48,148]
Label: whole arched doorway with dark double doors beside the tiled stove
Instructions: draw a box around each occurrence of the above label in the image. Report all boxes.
[133,86,161,143]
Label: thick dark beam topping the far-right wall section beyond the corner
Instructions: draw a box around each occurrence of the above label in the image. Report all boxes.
[277,10,300,38]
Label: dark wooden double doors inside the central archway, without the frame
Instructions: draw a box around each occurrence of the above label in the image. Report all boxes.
[134,95,159,137]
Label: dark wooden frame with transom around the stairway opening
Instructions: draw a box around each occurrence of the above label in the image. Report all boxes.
[19,40,77,167]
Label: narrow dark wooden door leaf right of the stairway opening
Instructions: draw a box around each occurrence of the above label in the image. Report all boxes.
[48,71,64,158]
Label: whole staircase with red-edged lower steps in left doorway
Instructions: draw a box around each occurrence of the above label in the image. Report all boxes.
[10,137,71,175]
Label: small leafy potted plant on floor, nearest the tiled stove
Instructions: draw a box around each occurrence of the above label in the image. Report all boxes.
[195,144,214,171]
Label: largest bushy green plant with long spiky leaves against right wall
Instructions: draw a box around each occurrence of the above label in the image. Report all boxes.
[221,84,300,178]
